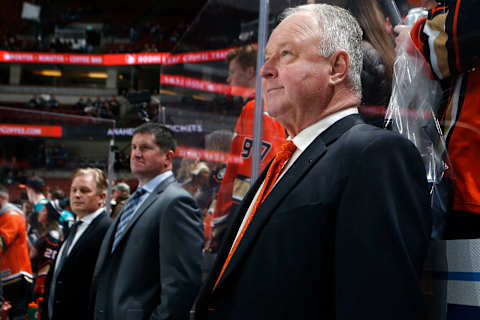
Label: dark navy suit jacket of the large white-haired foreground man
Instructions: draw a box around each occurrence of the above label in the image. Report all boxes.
[194,115,431,320]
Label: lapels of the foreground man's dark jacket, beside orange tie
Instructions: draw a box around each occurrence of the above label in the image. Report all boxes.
[218,115,362,287]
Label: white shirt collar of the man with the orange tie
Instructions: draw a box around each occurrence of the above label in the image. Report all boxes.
[289,106,358,151]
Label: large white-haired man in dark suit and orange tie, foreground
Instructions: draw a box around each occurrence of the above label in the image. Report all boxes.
[192,4,431,320]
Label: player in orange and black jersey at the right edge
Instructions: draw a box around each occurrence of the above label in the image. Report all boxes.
[395,0,480,239]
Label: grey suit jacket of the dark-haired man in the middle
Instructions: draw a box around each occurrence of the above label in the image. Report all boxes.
[92,177,204,320]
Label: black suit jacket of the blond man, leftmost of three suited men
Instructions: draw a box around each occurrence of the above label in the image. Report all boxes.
[42,212,112,320]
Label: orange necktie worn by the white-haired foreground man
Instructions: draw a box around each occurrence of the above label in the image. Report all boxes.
[213,140,297,290]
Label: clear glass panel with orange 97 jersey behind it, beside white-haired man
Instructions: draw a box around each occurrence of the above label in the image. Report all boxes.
[159,0,312,250]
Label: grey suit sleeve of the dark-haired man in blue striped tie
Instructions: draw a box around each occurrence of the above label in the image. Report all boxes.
[151,189,204,319]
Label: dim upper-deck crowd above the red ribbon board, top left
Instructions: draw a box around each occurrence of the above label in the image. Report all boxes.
[0,1,194,53]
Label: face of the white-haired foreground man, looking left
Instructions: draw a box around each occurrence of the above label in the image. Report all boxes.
[261,13,330,127]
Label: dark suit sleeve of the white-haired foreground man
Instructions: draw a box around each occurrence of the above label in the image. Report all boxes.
[334,134,431,320]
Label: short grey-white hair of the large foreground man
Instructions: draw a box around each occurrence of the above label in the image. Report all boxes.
[281,3,363,93]
